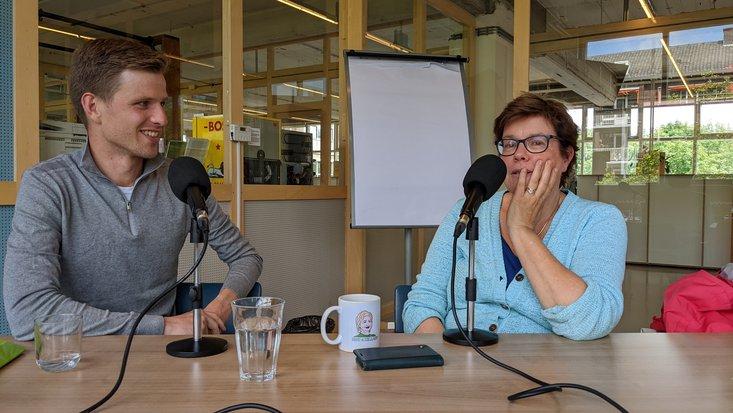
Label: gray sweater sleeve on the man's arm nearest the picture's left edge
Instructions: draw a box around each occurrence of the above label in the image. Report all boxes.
[3,170,163,340]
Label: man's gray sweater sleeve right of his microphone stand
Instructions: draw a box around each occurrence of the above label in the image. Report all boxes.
[206,195,262,297]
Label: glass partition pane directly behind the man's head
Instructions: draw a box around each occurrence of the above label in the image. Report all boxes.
[38,0,224,177]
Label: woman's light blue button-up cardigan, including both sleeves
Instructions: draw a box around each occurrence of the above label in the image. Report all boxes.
[402,192,627,340]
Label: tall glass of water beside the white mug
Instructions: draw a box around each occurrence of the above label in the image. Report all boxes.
[232,297,285,382]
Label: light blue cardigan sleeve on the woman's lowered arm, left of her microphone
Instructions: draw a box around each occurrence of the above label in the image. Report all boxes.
[402,202,461,333]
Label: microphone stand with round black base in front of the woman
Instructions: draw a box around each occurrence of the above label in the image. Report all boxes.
[443,217,499,347]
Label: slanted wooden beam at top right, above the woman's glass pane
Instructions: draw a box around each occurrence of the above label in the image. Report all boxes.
[528,6,733,55]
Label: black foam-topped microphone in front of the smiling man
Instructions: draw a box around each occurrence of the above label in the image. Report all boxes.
[168,156,211,231]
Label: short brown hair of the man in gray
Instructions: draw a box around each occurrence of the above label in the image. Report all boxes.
[69,38,168,125]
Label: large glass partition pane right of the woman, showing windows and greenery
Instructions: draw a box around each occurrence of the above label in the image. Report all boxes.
[530,0,733,269]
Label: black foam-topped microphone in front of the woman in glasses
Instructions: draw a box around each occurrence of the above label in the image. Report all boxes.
[453,154,506,238]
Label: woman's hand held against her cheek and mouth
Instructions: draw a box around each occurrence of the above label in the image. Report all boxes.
[505,160,561,237]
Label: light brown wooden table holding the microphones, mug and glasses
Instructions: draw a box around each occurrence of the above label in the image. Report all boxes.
[0,334,733,412]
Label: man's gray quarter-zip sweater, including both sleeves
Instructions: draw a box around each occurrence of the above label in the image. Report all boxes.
[3,148,262,340]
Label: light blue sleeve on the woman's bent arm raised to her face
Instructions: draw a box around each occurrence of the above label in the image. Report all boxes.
[542,204,627,340]
